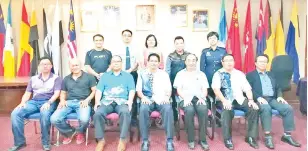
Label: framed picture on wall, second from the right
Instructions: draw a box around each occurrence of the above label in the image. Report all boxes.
[170,5,187,27]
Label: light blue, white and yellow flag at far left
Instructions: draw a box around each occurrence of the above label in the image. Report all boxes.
[3,0,15,78]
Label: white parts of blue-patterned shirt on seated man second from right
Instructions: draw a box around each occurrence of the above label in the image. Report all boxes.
[212,68,251,105]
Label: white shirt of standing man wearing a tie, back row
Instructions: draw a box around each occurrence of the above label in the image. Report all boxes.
[112,44,139,71]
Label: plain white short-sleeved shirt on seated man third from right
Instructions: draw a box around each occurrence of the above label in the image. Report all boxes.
[173,69,209,101]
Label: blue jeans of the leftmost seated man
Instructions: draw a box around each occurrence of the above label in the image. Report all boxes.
[11,100,57,146]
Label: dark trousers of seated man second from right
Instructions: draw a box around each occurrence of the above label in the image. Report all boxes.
[217,99,259,139]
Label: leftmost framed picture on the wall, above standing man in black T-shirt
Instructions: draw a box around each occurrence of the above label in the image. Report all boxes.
[80,10,98,32]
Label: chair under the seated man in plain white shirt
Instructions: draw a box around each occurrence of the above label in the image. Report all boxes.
[175,96,216,140]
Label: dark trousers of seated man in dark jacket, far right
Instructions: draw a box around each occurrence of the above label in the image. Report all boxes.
[258,98,295,132]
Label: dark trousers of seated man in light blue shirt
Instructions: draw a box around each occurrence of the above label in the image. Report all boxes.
[93,102,131,140]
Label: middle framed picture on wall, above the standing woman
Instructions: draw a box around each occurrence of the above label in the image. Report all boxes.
[136,5,155,30]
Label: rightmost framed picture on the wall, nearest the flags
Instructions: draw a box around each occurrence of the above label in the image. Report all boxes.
[192,9,209,31]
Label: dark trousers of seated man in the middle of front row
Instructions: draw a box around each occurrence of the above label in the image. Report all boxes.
[139,103,174,141]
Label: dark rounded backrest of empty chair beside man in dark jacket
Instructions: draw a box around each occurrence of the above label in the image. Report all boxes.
[271,55,294,91]
